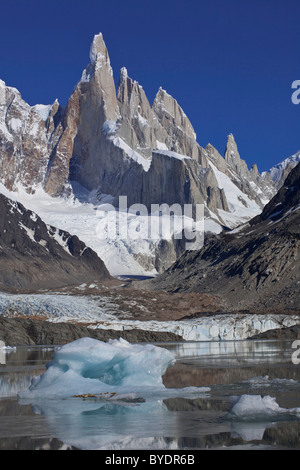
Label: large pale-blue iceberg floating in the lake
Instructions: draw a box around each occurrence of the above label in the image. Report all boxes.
[19,338,203,400]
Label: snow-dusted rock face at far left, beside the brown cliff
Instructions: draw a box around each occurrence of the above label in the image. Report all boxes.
[0,80,62,192]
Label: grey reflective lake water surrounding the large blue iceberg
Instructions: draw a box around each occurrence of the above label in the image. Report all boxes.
[0,340,300,451]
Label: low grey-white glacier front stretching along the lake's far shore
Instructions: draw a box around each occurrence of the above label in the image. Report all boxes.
[0,284,300,341]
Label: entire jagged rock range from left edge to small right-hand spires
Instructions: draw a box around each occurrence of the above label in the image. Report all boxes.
[0,33,275,226]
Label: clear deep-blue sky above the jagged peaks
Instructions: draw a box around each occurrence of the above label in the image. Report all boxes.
[0,0,300,171]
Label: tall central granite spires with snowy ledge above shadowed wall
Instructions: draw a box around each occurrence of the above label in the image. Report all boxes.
[68,35,233,215]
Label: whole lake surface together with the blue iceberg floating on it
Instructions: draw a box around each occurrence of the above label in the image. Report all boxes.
[0,339,300,451]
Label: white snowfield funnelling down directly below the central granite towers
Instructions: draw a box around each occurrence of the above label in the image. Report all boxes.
[0,179,196,276]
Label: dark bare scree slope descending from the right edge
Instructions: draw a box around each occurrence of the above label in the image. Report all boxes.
[142,163,300,311]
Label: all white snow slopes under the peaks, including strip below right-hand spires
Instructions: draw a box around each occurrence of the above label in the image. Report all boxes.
[0,158,284,276]
